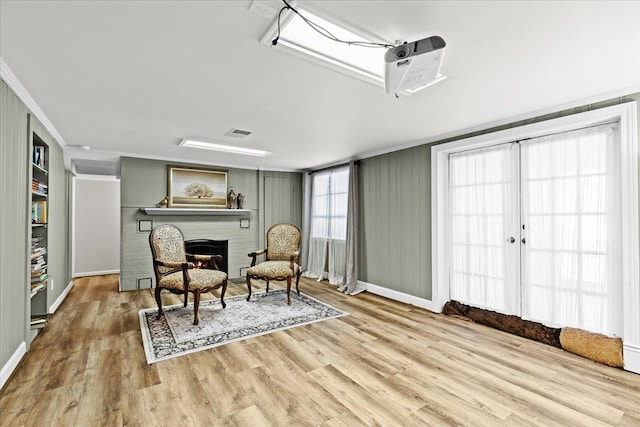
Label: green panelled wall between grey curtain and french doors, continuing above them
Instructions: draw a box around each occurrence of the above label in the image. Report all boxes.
[359,93,640,300]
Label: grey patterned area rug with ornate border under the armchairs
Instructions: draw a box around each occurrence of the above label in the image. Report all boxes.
[138,289,349,364]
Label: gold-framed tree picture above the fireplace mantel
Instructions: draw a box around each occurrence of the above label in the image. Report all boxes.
[167,166,227,209]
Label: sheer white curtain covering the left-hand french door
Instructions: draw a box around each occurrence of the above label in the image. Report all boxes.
[449,144,520,314]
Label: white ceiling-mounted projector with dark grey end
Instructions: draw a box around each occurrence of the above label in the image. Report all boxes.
[384,36,446,93]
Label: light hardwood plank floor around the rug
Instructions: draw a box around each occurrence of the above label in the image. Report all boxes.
[0,276,640,426]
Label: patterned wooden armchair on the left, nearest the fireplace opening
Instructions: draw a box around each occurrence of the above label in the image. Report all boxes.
[149,224,227,325]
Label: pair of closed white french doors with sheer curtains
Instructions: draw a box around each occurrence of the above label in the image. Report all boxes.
[449,125,622,336]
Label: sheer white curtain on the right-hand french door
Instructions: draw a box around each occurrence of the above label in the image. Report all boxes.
[521,125,623,336]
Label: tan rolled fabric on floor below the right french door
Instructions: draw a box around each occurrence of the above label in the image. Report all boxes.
[560,328,624,368]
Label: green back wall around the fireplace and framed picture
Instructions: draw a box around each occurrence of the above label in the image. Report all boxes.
[120,158,302,290]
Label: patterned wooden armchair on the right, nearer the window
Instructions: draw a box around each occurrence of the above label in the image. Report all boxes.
[247,224,301,304]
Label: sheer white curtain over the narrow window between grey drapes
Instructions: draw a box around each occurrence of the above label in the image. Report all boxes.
[304,167,349,285]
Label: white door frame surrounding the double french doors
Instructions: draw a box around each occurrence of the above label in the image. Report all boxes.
[431,102,640,373]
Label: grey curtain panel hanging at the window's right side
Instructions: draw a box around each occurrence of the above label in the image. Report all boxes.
[339,160,360,294]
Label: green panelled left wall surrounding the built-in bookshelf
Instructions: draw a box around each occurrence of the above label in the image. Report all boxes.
[0,81,71,376]
